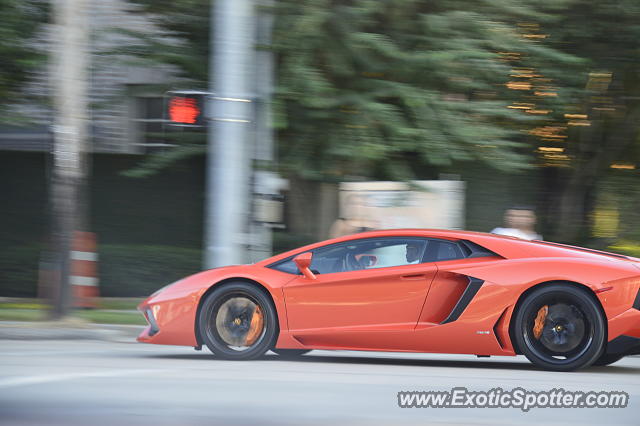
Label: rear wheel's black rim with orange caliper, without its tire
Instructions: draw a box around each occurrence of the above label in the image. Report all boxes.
[523,293,595,365]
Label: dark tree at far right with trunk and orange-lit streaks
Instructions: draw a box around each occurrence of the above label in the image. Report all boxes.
[516,0,640,242]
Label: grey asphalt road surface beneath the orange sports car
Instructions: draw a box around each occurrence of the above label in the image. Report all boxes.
[0,340,640,426]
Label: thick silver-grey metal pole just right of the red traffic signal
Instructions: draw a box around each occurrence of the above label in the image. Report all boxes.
[204,0,255,268]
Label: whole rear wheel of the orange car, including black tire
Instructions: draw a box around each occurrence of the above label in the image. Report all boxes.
[512,283,606,371]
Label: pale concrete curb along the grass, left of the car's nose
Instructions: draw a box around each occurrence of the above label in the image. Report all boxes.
[0,321,144,343]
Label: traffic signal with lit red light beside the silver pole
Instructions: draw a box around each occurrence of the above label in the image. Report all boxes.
[166,90,207,127]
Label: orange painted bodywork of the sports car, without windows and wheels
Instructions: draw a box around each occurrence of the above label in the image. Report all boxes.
[138,229,640,355]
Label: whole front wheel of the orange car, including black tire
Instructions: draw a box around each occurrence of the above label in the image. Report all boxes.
[198,282,278,360]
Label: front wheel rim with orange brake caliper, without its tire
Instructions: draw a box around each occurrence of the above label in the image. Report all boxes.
[207,292,267,353]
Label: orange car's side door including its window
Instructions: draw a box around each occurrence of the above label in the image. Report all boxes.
[283,237,437,345]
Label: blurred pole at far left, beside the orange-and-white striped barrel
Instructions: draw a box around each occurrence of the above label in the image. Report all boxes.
[50,0,88,318]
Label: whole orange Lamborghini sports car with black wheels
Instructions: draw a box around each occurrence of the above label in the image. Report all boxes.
[138,229,640,371]
